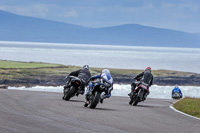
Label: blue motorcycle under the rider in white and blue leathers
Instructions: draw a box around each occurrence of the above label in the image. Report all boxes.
[84,79,111,109]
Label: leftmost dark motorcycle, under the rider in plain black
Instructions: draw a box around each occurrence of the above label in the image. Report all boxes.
[62,76,82,101]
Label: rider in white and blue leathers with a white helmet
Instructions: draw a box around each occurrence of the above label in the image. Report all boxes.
[85,69,113,103]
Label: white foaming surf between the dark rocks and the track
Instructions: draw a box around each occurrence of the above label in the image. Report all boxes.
[8,84,200,99]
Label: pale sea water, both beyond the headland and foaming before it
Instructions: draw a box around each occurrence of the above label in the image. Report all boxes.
[0,41,200,98]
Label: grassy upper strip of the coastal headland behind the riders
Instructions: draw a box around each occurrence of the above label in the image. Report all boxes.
[0,60,198,80]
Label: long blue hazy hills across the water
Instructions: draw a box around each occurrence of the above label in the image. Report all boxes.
[0,10,200,48]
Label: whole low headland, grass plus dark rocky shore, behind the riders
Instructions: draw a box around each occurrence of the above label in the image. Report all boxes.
[0,60,200,86]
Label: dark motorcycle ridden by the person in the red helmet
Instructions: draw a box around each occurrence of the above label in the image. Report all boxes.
[129,82,149,106]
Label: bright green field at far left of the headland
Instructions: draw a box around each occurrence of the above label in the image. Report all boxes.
[0,60,60,68]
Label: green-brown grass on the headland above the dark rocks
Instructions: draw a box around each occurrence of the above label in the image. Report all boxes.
[0,60,195,77]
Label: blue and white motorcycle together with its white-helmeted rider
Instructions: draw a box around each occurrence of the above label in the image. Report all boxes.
[84,69,113,109]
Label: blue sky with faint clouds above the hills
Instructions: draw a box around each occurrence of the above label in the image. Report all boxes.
[0,0,200,33]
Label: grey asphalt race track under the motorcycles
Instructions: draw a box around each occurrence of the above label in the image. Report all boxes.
[0,90,200,133]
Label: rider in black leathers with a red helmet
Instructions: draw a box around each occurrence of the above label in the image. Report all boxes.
[128,67,153,100]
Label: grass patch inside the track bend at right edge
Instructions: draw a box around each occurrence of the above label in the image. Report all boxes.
[173,97,200,118]
